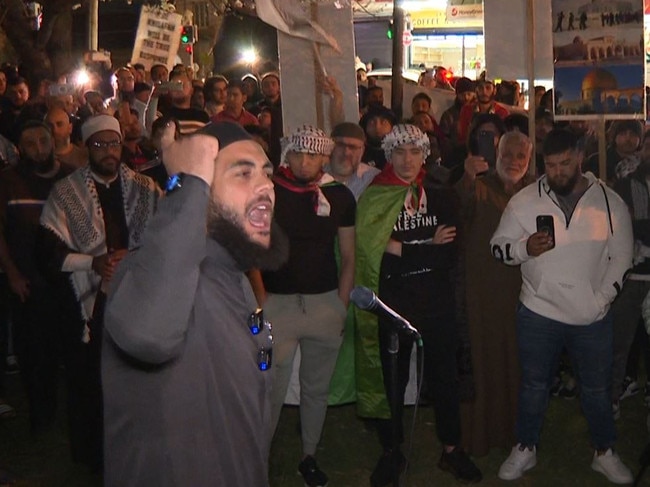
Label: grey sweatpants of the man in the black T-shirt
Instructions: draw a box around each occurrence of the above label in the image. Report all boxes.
[264,290,346,455]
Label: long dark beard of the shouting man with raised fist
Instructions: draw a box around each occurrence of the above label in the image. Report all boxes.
[208,201,289,271]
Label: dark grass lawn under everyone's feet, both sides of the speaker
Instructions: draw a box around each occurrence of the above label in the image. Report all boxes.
[0,375,650,487]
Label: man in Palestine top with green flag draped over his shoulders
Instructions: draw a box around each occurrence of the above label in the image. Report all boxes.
[354,125,481,486]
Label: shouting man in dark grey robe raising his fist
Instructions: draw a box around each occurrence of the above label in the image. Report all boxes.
[102,122,288,487]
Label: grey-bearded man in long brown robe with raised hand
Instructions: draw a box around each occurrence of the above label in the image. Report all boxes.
[455,131,535,456]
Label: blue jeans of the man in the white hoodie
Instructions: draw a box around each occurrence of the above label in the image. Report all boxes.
[516,303,616,450]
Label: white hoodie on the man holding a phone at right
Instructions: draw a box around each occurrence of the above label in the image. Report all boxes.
[490,173,633,325]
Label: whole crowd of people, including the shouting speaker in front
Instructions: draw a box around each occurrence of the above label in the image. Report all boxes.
[0,53,650,487]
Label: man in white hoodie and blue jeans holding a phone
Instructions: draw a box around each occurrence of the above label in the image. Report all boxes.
[490,130,633,484]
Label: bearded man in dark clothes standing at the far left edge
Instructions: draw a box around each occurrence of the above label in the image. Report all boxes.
[0,121,68,434]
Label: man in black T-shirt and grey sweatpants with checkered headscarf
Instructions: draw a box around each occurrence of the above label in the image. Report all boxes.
[263,125,356,487]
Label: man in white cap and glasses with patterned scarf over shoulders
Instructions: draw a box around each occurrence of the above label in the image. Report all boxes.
[39,115,160,468]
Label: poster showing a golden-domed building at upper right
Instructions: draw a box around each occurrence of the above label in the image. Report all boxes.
[551,0,645,120]
